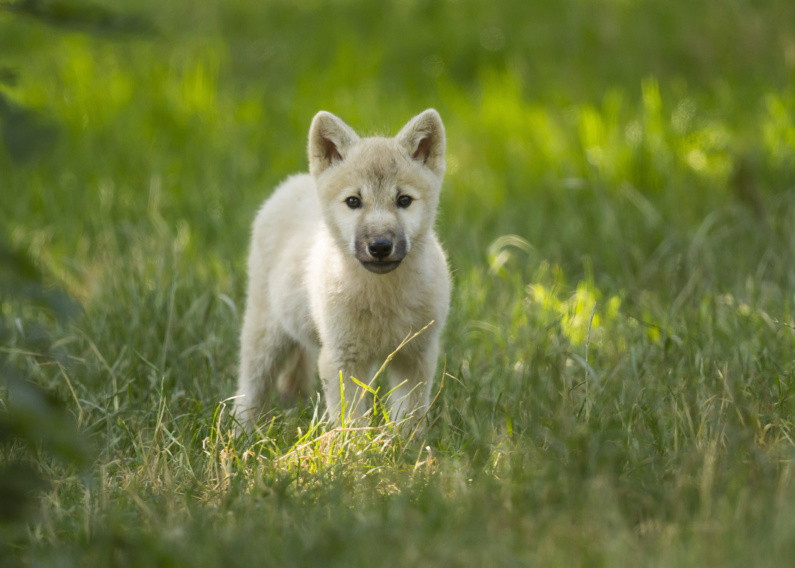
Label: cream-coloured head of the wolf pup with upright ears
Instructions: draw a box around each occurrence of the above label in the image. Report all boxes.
[309,109,445,274]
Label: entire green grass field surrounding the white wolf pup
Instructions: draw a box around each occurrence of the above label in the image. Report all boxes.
[0,0,795,567]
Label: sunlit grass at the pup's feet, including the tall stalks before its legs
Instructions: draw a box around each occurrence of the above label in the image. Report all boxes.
[202,321,444,502]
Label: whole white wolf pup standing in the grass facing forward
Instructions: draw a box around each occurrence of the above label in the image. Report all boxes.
[235,109,450,427]
